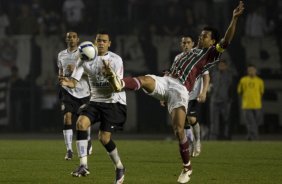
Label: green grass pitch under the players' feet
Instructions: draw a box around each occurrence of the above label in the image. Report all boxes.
[0,140,282,184]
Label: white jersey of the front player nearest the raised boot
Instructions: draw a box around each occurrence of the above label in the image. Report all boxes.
[72,51,126,105]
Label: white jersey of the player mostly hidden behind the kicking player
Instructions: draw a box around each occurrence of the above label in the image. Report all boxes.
[174,52,209,100]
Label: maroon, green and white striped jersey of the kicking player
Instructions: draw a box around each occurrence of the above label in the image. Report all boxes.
[170,46,221,91]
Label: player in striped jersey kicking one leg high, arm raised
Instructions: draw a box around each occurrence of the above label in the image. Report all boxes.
[104,1,244,183]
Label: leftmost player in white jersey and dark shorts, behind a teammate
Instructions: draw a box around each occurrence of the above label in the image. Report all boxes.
[57,32,92,160]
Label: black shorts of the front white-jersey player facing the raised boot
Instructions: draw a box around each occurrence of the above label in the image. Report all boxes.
[79,101,127,132]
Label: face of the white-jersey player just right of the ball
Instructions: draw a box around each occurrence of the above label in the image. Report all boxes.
[95,34,111,56]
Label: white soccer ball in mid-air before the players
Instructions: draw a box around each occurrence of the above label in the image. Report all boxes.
[78,41,98,61]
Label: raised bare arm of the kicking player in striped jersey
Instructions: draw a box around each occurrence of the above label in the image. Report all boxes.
[223,1,245,44]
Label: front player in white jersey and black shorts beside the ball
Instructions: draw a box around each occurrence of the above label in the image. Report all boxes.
[61,30,127,184]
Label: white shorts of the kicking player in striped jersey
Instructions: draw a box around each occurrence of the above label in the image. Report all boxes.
[144,75,189,113]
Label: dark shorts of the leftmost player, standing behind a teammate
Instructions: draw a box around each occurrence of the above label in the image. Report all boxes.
[59,87,90,115]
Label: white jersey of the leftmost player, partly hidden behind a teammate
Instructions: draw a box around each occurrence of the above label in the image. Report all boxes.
[57,49,90,98]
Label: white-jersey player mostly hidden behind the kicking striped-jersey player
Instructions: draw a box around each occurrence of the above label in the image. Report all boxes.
[174,35,210,157]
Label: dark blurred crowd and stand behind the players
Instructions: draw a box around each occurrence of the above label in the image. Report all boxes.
[0,0,282,138]
